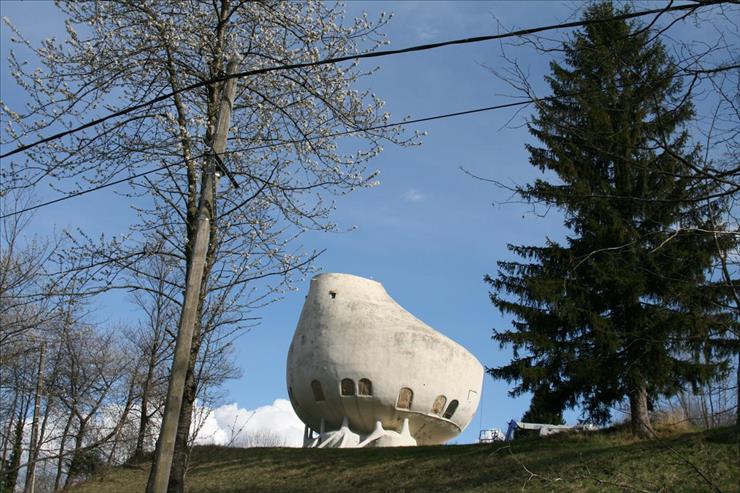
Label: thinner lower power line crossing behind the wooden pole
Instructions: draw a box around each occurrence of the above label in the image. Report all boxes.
[0,64,740,219]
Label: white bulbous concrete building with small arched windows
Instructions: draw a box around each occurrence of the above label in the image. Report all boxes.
[287,274,483,447]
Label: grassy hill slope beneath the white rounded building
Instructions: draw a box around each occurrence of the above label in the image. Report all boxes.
[73,427,740,493]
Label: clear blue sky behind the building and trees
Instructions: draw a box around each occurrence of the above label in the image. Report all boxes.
[0,1,728,443]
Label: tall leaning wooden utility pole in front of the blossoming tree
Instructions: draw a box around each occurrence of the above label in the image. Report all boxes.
[147,60,238,493]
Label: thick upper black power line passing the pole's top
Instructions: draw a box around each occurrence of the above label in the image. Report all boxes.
[0,0,728,159]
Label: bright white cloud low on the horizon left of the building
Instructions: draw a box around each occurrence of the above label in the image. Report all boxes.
[195,399,304,447]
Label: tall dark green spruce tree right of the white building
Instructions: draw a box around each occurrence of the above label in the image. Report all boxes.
[486,2,734,437]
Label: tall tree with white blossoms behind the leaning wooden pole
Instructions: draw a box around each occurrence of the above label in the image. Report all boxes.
[2,0,410,490]
